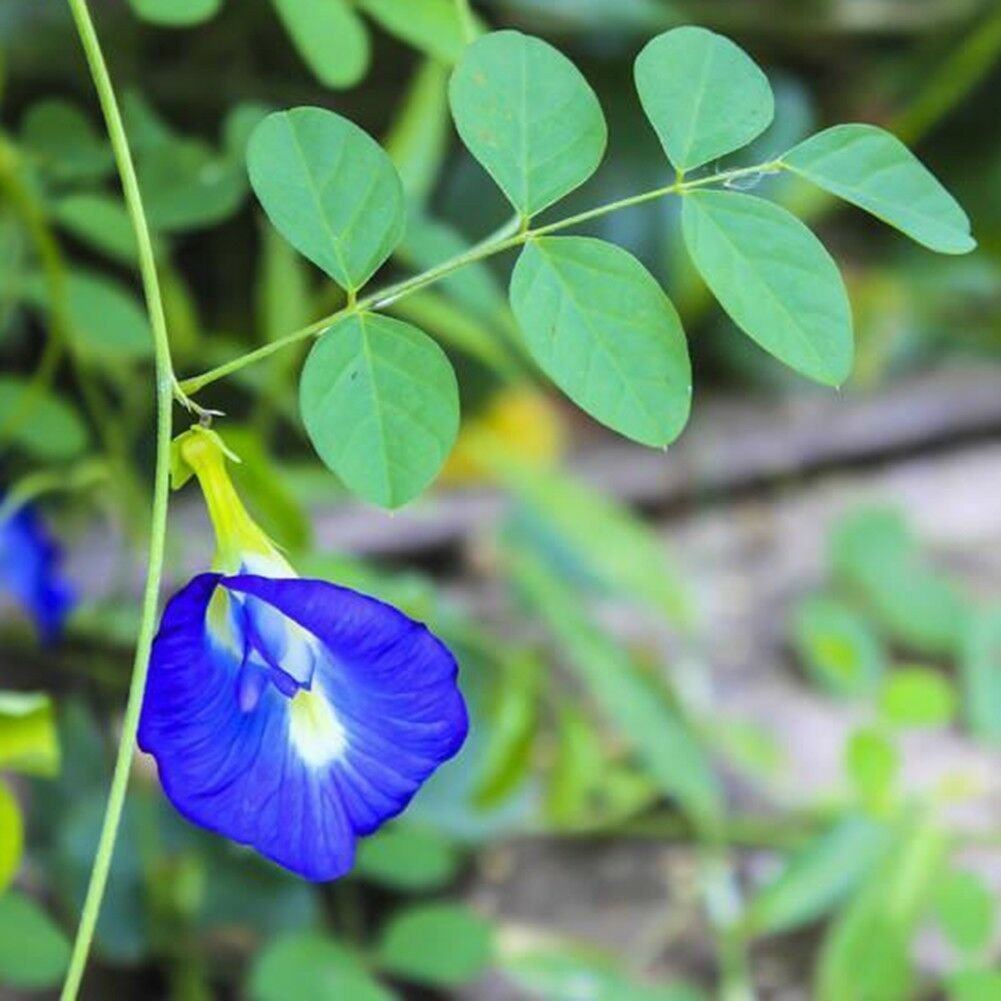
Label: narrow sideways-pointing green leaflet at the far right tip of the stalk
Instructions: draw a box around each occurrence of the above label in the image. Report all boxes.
[782,125,977,254]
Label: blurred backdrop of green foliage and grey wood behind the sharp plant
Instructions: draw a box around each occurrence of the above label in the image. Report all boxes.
[0,0,1001,1001]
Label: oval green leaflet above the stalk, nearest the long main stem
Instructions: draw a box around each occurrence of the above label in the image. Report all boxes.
[247,108,404,290]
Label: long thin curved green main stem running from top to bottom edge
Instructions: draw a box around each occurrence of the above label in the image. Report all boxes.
[60,0,176,1001]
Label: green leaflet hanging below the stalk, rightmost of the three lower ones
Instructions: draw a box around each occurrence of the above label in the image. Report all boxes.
[682,190,854,385]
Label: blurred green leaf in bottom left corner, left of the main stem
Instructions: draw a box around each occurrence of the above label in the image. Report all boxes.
[0,890,69,989]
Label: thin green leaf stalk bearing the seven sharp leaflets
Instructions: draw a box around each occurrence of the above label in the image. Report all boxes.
[179,161,772,396]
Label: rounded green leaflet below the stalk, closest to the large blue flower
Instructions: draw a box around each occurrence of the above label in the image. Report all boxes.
[299,313,458,508]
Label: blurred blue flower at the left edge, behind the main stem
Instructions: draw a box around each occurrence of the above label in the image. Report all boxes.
[0,505,75,643]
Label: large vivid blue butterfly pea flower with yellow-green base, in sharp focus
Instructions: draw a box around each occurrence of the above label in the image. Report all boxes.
[138,428,468,880]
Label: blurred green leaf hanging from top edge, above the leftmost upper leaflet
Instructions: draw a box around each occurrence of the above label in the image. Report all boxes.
[271,0,369,89]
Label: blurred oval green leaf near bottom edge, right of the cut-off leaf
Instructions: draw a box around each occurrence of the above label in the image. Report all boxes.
[376,904,493,986]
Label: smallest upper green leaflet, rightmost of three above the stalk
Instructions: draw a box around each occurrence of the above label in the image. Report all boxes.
[635,27,775,171]
